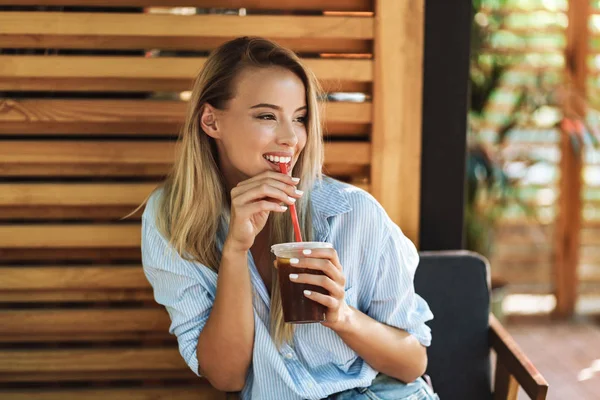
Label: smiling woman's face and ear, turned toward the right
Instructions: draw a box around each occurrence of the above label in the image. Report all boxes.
[202,67,308,187]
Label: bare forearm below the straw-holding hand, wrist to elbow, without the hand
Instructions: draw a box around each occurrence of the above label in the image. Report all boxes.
[198,244,254,392]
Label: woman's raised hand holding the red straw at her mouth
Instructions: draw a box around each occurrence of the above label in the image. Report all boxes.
[226,171,303,251]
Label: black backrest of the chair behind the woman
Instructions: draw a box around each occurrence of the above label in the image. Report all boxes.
[415,251,491,400]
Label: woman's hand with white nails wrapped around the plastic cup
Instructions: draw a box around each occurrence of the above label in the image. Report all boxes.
[290,249,351,331]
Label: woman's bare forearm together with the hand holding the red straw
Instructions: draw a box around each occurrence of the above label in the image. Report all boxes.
[198,171,302,392]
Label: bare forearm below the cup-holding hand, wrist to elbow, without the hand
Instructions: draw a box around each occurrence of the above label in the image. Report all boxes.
[330,306,427,383]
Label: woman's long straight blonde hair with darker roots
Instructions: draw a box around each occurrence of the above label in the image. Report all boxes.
[156,37,324,346]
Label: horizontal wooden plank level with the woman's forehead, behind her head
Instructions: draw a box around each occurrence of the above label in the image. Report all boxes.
[0,56,373,92]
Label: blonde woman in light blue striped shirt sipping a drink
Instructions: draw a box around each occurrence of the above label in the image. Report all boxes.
[142,38,437,400]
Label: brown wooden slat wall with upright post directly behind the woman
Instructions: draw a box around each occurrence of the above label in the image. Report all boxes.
[0,0,423,400]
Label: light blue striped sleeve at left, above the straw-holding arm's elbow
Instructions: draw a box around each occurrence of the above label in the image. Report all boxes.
[142,219,214,376]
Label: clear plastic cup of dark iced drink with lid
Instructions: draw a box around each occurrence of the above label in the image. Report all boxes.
[271,242,333,324]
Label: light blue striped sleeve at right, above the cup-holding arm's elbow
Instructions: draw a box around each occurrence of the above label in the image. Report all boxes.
[366,223,433,346]
